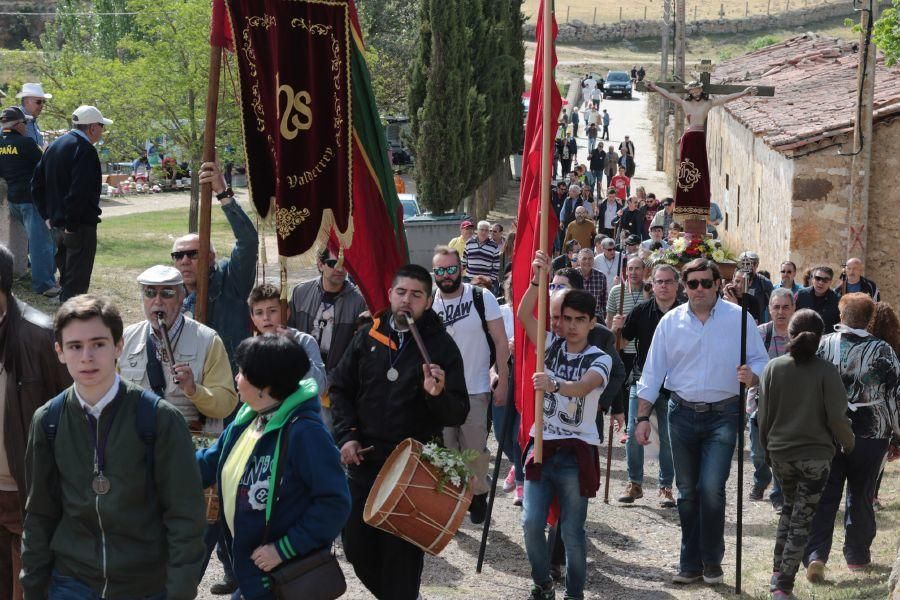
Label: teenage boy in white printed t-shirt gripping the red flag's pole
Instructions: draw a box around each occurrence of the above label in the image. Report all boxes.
[516,251,612,599]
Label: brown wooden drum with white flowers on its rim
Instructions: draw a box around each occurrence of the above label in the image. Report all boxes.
[363,438,472,555]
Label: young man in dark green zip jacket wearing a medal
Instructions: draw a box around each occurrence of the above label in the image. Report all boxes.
[21,295,205,600]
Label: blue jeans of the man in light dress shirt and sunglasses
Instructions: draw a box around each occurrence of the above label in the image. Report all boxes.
[669,400,740,572]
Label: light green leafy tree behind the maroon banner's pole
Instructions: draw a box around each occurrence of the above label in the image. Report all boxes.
[21,0,240,231]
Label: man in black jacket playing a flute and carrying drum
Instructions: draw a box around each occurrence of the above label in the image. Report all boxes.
[330,265,469,600]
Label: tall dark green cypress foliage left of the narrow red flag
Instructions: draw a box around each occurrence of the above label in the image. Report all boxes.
[409,0,525,214]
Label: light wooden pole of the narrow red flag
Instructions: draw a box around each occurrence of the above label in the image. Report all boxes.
[534,0,556,464]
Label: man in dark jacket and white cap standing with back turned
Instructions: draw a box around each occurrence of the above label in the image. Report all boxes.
[31,106,112,302]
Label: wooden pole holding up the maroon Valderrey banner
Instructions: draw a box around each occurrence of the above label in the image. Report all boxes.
[194,46,225,323]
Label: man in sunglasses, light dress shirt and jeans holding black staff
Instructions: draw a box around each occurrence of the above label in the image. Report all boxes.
[635,258,769,584]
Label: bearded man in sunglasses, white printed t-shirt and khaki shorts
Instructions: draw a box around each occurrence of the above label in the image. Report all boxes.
[432,246,509,524]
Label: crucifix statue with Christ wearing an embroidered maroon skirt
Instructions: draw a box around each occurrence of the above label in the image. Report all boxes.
[636,60,775,236]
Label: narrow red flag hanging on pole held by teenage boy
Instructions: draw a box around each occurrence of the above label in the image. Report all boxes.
[512,0,562,448]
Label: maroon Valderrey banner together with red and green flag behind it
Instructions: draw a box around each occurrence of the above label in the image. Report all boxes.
[210,0,407,312]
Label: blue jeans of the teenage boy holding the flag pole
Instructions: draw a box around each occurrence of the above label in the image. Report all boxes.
[522,452,588,600]
